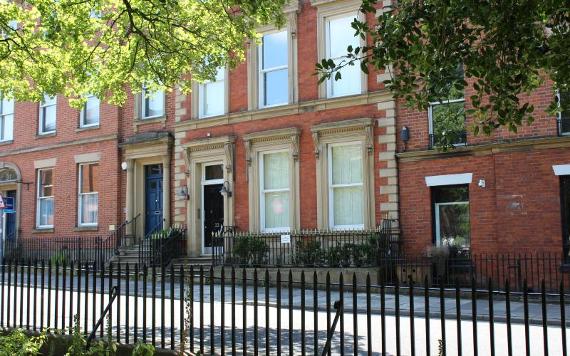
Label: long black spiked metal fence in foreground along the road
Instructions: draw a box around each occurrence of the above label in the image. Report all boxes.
[0,263,569,355]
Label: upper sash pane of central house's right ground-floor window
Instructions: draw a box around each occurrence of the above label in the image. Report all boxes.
[331,145,363,185]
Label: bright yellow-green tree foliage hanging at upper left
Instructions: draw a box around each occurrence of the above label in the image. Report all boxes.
[0,0,285,105]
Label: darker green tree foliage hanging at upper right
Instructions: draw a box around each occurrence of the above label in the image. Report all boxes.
[317,0,570,134]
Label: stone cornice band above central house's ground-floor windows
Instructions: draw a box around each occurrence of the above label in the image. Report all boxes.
[174,90,393,132]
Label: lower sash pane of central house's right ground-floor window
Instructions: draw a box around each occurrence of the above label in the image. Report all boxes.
[333,186,364,226]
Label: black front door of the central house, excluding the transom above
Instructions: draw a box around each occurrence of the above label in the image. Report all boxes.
[203,184,224,254]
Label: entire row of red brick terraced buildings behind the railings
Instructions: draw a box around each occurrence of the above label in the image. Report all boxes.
[0,0,570,262]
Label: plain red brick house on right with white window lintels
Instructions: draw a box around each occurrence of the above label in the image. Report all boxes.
[396,83,570,262]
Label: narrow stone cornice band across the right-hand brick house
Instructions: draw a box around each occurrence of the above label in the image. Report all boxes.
[396,136,570,162]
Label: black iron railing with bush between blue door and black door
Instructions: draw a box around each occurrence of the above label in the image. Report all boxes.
[139,221,186,266]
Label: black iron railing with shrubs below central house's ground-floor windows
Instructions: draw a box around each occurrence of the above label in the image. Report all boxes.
[214,220,399,267]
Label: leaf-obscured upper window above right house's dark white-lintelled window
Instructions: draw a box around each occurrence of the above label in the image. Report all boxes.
[432,101,466,146]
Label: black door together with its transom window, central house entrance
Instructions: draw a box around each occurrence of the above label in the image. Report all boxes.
[201,163,224,255]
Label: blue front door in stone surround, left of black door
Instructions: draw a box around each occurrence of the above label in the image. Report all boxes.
[144,164,163,235]
